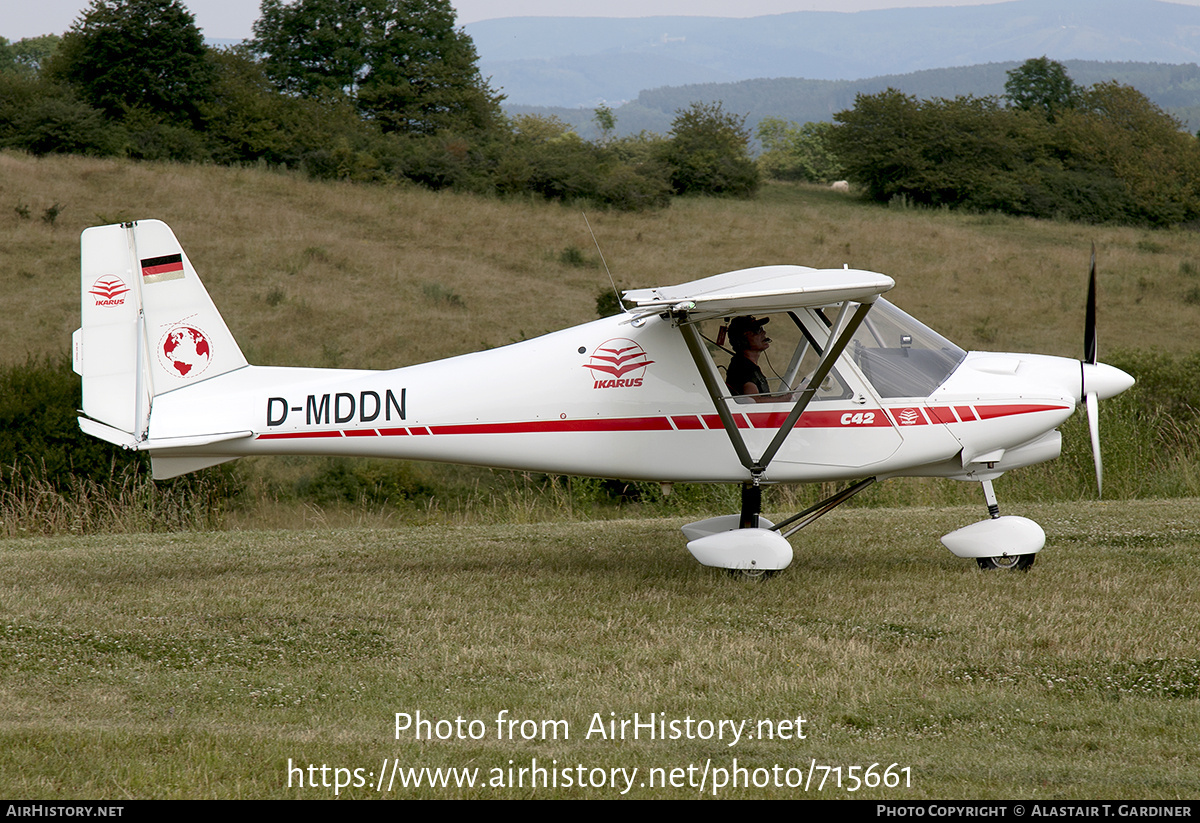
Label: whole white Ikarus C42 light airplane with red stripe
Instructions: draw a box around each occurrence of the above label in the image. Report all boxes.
[73,220,1133,576]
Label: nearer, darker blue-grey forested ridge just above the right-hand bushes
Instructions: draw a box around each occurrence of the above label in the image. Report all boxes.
[505,60,1200,138]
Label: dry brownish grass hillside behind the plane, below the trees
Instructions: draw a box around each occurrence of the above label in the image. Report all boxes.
[0,147,1200,368]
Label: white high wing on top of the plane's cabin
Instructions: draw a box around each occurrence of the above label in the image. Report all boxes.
[624,265,895,322]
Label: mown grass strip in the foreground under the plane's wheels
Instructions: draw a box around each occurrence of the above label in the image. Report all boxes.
[0,500,1200,799]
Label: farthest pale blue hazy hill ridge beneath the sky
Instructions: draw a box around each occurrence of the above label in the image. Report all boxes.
[466,0,1200,108]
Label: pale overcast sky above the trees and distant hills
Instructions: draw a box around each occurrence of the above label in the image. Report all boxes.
[9,0,1200,41]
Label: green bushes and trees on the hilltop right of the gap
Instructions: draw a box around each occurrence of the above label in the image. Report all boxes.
[787,56,1200,226]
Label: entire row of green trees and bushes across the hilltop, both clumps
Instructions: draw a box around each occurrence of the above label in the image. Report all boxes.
[0,0,1200,226]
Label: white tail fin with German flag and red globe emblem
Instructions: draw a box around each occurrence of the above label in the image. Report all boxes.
[73,220,246,446]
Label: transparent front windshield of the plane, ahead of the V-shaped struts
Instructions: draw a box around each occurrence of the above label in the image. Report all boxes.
[846,298,967,397]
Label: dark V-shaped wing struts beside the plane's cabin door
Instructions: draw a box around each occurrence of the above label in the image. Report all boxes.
[674,300,875,477]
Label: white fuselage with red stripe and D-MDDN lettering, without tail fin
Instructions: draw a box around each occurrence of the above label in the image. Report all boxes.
[149,316,1079,482]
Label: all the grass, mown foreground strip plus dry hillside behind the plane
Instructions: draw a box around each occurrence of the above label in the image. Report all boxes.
[0,152,1200,799]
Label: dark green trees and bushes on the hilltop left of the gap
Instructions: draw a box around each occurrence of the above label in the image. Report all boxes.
[0,0,758,209]
